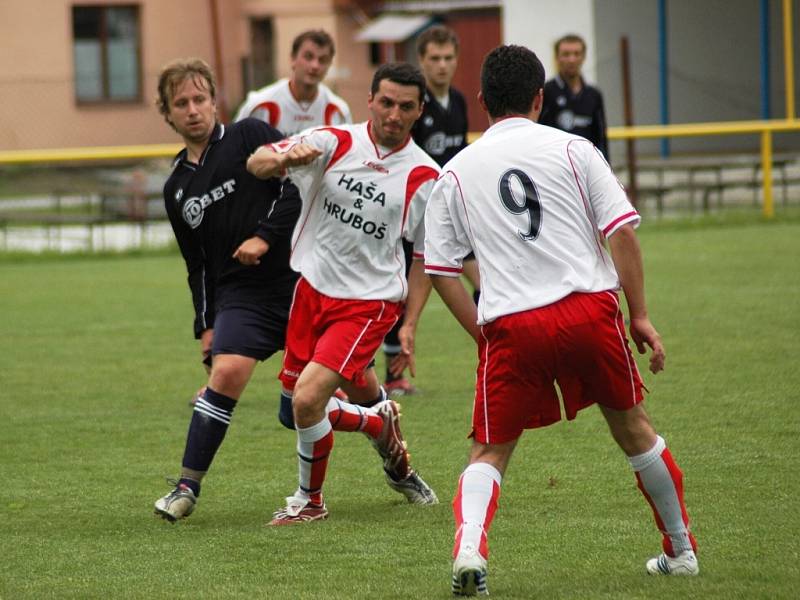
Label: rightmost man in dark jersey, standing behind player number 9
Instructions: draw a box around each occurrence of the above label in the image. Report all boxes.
[539,33,610,161]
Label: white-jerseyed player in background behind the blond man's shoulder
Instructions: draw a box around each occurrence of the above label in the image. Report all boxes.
[235,29,352,136]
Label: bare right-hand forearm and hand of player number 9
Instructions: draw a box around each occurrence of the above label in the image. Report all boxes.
[608,225,666,373]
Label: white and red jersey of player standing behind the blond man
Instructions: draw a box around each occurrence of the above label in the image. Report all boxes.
[235,79,353,136]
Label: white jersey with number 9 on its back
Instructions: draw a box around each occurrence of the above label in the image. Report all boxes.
[425,118,640,324]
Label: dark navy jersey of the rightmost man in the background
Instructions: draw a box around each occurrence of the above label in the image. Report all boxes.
[539,77,610,161]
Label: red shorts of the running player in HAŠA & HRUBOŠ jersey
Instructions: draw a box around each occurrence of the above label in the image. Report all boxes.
[279,277,403,390]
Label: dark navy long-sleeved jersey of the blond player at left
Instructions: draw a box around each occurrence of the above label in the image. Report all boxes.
[164,119,300,337]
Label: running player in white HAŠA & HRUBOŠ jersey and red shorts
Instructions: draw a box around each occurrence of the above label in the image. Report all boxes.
[247,63,439,525]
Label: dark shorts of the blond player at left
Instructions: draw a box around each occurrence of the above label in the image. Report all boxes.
[211,304,289,360]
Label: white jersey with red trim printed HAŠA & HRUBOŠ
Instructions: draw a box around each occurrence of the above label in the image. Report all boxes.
[272,122,439,302]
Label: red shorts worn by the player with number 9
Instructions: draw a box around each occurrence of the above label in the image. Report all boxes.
[472,292,643,444]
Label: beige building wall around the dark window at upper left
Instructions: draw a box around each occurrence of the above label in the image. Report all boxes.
[0,0,372,150]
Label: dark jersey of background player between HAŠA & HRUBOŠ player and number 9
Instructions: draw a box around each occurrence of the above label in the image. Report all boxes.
[411,88,467,167]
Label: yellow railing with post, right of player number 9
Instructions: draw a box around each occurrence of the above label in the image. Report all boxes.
[608,119,800,217]
